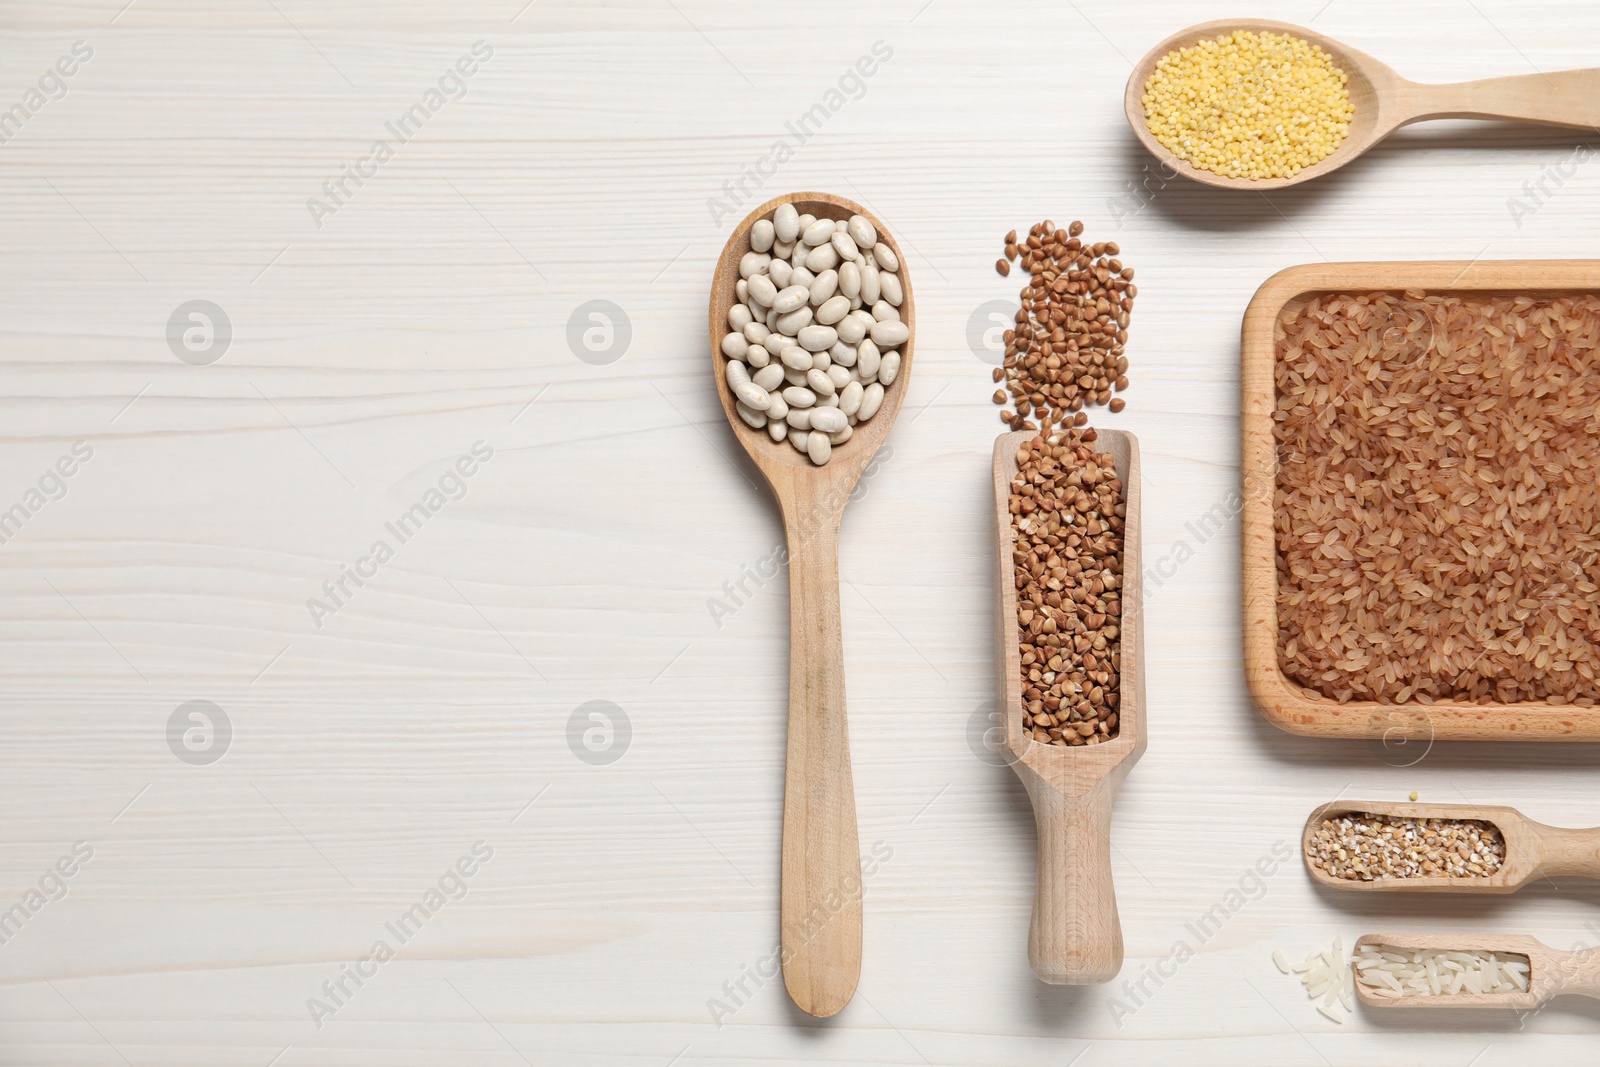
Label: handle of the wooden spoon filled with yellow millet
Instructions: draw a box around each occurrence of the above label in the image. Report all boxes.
[1402,67,1600,130]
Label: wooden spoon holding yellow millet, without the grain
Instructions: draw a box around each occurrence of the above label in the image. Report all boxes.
[1123,19,1600,192]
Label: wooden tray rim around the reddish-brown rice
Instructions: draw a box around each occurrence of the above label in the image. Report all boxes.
[1240,259,1600,742]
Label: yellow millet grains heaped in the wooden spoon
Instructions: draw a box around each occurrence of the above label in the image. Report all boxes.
[1142,30,1355,179]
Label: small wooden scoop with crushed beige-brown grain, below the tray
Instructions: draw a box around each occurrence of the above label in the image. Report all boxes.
[1301,800,1600,893]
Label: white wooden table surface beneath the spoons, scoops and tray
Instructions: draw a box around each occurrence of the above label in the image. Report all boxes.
[9,0,1600,1067]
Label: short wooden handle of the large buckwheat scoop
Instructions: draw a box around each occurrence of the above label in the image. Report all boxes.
[1027,782,1122,985]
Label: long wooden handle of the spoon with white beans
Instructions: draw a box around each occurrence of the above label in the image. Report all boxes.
[781,507,861,1016]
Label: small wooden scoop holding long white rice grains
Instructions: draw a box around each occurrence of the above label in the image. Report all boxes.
[1355,934,1600,1011]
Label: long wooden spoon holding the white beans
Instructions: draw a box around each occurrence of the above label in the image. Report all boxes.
[710,192,917,1016]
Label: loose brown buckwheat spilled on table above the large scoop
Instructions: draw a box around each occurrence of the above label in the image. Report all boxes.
[995,219,1139,434]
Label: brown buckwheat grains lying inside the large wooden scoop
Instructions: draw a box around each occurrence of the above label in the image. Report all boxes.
[1010,429,1128,745]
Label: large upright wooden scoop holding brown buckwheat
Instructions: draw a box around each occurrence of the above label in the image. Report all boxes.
[994,430,1146,985]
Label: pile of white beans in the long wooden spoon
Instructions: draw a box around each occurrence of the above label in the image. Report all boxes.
[722,203,910,466]
